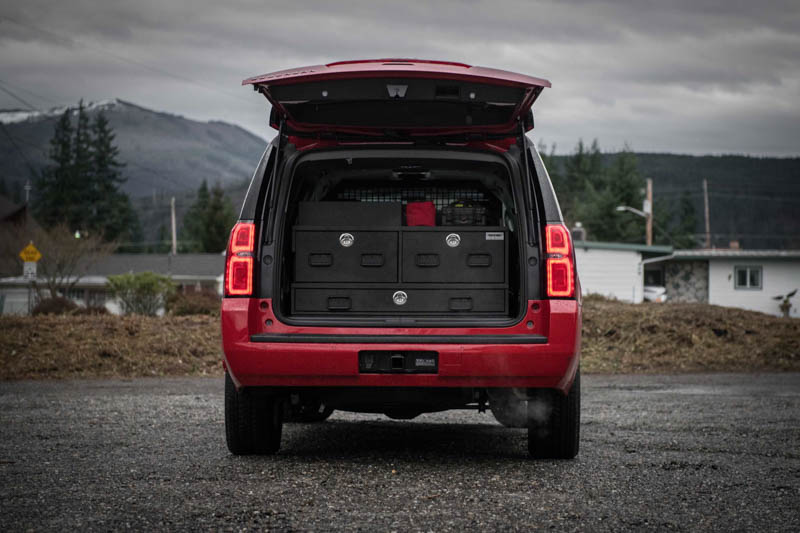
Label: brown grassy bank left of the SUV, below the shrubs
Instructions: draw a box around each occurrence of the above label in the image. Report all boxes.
[0,315,222,380]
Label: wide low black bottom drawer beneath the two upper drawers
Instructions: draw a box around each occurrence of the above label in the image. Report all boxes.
[292,286,507,315]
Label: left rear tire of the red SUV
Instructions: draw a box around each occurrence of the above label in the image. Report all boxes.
[225,372,283,455]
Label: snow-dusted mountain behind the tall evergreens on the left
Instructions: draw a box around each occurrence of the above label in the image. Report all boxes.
[0,100,266,199]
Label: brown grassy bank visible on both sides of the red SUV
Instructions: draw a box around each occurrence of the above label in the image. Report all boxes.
[0,297,800,380]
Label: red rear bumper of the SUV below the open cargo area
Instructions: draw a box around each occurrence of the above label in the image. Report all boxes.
[221,298,581,391]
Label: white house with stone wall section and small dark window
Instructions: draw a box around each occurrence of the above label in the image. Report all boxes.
[646,249,800,317]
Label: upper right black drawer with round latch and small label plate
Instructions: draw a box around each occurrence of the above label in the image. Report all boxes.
[402,226,507,283]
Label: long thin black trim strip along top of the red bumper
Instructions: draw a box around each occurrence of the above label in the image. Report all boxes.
[250,333,547,344]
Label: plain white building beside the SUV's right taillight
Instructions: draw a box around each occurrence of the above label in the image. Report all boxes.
[574,241,672,303]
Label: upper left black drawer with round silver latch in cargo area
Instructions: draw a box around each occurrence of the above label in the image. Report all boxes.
[294,226,399,283]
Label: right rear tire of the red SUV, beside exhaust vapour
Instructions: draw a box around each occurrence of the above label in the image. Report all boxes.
[528,369,581,459]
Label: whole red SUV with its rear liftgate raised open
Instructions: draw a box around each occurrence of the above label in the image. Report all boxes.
[222,59,581,458]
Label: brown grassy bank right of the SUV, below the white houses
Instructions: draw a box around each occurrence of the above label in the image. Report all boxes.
[582,297,800,373]
